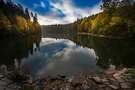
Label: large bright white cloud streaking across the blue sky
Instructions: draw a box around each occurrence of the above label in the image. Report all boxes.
[38,0,101,25]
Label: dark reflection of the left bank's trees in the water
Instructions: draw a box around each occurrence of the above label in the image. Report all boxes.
[0,35,41,65]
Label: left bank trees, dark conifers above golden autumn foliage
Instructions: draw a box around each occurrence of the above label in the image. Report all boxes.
[0,0,41,35]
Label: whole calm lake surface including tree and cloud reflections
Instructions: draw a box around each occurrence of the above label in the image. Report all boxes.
[0,31,135,77]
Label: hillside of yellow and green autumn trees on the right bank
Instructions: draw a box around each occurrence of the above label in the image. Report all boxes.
[77,0,135,38]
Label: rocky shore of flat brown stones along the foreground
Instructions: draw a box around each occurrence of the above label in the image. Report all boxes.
[0,69,135,90]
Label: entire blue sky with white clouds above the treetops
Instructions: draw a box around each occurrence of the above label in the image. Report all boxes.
[13,0,101,25]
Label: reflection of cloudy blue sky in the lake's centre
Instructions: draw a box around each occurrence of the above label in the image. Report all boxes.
[22,38,98,76]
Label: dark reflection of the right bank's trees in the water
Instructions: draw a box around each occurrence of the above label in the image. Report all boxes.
[77,35,135,69]
